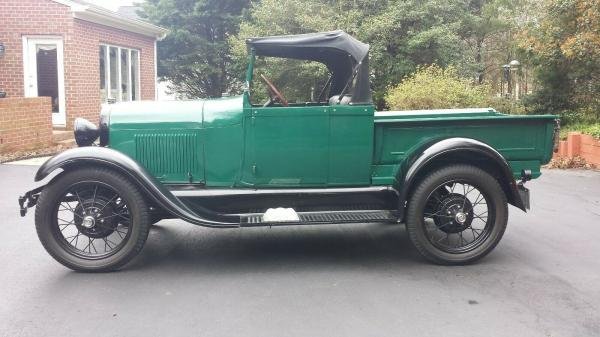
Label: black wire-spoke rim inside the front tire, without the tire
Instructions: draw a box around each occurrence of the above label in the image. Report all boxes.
[54,182,132,259]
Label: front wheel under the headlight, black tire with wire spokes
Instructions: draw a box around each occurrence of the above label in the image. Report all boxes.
[35,168,150,272]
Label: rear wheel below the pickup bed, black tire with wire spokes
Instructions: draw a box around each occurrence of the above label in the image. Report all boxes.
[406,165,508,265]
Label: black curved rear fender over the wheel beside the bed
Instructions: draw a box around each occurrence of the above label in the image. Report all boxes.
[396,138,527,219]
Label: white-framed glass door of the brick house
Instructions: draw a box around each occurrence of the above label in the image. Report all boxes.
[23,37,66,126]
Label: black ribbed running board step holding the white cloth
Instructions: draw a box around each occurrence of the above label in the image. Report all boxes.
[240,210,398,227]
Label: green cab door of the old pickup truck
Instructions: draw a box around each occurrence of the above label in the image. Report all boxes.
[244,106,329,187]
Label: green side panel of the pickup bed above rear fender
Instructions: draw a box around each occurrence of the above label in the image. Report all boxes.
[372,114,554,185]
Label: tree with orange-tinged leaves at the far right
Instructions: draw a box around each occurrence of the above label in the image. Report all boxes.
[519,0,600,119]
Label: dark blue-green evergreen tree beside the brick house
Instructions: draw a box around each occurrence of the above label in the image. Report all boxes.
[141,0,249,98]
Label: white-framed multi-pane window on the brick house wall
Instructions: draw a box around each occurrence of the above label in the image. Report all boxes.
[99,45,140,103]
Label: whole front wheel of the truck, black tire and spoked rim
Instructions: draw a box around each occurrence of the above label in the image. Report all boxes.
[35,168,149,272]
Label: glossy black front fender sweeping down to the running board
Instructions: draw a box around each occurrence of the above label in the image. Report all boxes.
[35,146,240,227]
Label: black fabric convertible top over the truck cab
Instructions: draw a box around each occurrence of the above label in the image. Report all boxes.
[246,30,371,103]
